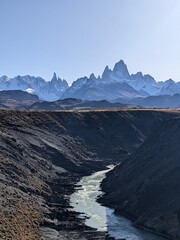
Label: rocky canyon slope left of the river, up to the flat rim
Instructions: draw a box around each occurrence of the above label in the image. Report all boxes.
[0,110,178,240]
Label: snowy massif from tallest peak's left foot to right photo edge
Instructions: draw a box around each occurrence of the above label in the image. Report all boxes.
[62,60,180,101]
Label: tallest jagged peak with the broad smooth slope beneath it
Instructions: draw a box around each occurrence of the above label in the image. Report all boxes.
[62,60,149,101]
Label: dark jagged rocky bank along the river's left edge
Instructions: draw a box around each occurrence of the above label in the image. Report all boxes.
[40,172,113,240]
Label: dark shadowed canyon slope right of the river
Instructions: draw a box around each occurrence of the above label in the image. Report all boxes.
[102,113,180,239]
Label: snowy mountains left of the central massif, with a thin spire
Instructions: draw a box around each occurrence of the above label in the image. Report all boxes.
[0,73,68,101]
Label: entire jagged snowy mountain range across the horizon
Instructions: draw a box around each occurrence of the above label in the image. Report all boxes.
[0,60,180,101]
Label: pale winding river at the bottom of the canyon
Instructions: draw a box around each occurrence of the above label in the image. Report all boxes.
[70,167,164,240]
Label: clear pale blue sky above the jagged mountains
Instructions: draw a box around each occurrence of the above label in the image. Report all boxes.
[0,0,180,83]
